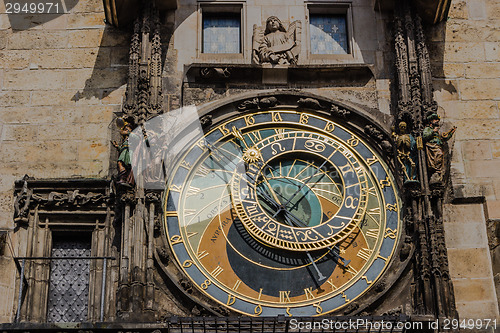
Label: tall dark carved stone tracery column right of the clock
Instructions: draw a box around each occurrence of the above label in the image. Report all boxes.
[394,1,457,318]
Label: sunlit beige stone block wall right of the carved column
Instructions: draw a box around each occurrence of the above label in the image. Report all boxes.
[429,0,500,318]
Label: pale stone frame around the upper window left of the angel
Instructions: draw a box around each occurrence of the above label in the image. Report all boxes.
[195,0,247,63]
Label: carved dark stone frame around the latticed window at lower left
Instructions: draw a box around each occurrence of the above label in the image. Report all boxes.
[14,179,117,323]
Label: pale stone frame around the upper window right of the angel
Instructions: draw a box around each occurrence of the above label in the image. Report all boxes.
[302,0,358,64]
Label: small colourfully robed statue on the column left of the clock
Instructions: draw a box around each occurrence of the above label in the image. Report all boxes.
[111,118,135,186]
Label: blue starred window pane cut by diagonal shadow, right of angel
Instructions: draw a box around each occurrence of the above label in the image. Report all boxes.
[309,13,350,54]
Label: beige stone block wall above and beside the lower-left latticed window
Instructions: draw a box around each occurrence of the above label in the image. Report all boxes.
[0,0,130,322]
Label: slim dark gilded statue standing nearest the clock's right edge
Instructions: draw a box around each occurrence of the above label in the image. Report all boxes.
[392,121,417,183]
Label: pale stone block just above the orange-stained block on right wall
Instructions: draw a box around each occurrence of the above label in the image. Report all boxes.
[444,222,488,249]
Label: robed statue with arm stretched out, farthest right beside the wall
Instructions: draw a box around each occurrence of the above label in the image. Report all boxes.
[422,113,457,184]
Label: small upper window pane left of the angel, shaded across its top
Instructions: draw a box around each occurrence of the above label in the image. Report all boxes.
[202,10,241,53]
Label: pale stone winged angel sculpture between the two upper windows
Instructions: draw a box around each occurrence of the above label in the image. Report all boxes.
[253,16,301,65]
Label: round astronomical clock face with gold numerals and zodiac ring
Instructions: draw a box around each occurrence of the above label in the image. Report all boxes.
[165,110,401,316]
